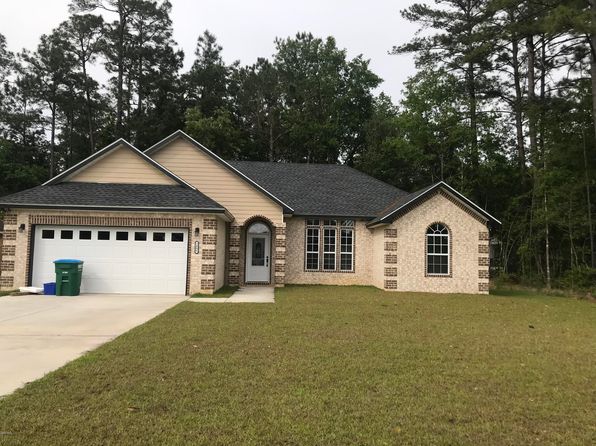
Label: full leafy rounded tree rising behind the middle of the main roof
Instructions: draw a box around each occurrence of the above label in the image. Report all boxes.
[273,33,381,163]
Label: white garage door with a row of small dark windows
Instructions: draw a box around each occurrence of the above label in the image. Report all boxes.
[32,225,188,294]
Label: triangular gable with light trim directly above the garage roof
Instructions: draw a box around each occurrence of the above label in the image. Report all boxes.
[44,139,194,189]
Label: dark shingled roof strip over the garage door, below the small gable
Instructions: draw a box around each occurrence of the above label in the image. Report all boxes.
[0,182,225,212]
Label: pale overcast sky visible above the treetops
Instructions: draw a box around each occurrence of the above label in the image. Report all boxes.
[0,0,417,101]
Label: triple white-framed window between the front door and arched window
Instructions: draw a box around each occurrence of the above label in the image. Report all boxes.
[305,219,354,272]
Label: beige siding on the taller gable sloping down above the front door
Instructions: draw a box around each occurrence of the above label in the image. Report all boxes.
[153,138,283,225]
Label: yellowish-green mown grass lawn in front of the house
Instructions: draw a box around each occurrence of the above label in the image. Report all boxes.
[0,287,596,445]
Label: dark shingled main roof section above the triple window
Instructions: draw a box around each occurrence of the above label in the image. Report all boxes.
[229,161,408,218]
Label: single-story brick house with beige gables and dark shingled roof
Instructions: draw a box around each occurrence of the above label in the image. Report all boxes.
[0,131,499,294]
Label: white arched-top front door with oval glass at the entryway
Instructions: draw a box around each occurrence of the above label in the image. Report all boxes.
[245,223,271,283]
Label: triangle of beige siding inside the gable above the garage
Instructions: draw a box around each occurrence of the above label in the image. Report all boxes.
[66,146,177,184]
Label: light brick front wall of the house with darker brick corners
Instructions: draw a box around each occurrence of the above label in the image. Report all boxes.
[0,194,490,293]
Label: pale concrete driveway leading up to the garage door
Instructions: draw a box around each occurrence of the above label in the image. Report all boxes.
[0,294,186,395]
